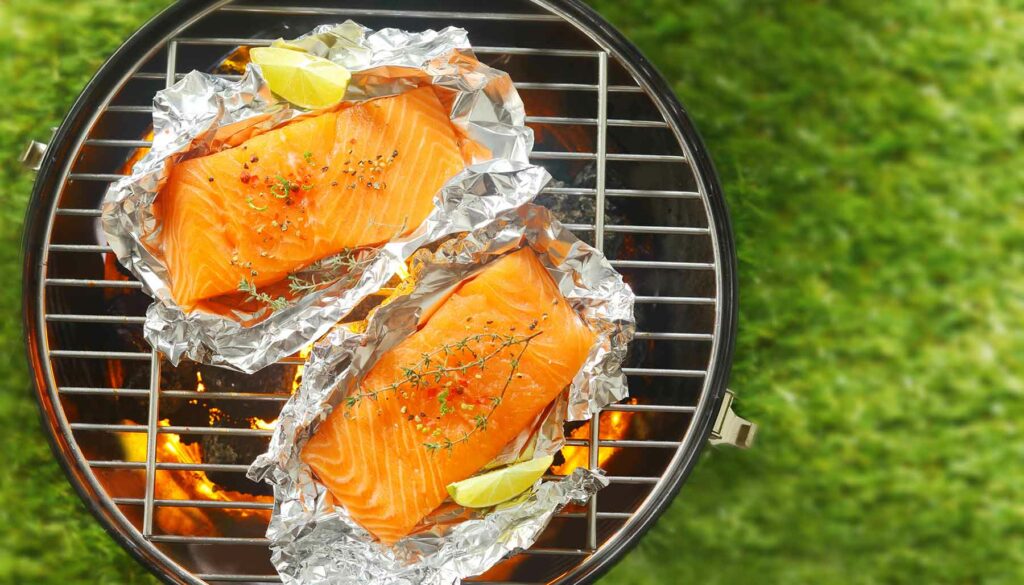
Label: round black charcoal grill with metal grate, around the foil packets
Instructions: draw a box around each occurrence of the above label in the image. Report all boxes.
[24,0,754,583]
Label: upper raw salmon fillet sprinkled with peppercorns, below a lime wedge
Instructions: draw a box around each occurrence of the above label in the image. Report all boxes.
[157,86,465,308]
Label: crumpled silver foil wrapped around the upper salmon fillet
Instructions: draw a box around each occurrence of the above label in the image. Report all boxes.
[100,20,536,373]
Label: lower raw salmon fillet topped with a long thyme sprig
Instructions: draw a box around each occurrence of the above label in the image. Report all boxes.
[302,248,596,543]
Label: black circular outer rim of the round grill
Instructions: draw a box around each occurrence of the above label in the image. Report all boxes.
[22,0,738,584]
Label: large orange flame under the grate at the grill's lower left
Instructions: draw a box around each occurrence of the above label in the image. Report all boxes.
[118,419,273,536]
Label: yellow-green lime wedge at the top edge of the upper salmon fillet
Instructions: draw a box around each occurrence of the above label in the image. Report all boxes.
[249,47,352,110]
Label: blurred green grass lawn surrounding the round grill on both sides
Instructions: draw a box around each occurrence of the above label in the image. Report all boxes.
[0,0,1024,585]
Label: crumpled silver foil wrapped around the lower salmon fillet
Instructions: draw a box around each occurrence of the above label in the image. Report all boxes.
[248,204,635,585]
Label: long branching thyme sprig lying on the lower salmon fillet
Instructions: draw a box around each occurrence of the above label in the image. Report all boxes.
[345,331,542,452]
